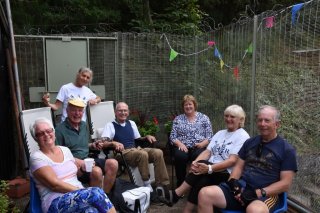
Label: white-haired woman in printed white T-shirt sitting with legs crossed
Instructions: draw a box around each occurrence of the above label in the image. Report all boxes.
[173,105,249,212]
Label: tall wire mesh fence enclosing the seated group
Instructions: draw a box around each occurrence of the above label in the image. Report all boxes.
[16,0,320,212]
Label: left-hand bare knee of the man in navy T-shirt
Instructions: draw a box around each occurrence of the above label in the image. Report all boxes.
[198,186,227,213]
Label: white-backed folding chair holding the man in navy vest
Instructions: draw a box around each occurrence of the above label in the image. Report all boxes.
[87,101,155,186]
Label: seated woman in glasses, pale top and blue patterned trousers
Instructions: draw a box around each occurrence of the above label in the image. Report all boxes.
[30,118,116,213]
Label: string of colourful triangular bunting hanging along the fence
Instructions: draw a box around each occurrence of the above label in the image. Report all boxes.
[160,0,314,80]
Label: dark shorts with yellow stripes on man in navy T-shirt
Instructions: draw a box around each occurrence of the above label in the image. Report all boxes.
[219,182,280,212]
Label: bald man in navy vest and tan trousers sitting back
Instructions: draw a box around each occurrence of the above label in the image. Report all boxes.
[102,102,170,194]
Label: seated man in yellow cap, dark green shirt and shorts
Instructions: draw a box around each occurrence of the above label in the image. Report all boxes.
[56,98,118,193]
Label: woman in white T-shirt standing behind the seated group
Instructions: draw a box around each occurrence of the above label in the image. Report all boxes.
[42,67,101,122]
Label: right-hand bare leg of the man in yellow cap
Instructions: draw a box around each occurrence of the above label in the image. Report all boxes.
[103,159,118,193]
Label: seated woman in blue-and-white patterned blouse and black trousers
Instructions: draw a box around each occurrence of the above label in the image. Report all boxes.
[170,95,213,187]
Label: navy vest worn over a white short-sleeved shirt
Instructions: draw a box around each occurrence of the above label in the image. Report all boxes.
[112,121,135,149]
